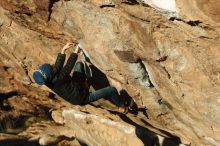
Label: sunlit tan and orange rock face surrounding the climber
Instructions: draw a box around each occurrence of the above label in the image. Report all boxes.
[0,0,220,145]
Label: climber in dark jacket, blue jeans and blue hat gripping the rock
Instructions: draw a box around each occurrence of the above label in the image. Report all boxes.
[33,43,128,113]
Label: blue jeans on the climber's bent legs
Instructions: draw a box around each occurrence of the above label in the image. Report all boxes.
[73,62,122,106]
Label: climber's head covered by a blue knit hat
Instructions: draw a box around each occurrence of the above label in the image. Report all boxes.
[33,64,54,85]
